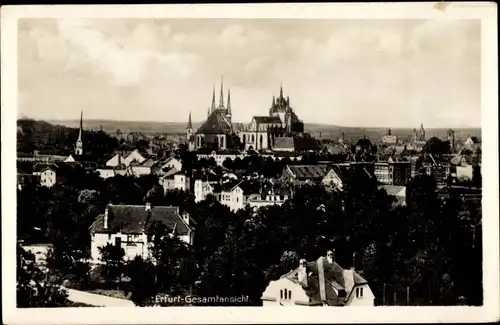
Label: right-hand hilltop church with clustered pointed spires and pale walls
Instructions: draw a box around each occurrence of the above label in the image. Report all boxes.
[239,87,304,150]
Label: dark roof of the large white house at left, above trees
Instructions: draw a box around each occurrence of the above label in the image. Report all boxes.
[90,205,192,236]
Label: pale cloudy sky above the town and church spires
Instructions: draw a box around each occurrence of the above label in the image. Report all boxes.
[18,18,481,128]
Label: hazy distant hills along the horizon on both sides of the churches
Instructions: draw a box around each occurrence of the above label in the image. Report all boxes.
[48,120,481,140]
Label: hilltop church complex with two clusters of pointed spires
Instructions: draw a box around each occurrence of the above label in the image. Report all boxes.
[186,82,304,151]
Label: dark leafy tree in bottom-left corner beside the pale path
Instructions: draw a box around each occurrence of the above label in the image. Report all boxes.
[17,246,68,308]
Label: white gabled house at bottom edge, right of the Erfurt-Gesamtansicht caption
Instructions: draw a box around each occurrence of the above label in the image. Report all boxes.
[261,251,375,307]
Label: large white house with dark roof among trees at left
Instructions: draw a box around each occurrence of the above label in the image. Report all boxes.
[90,203,196,263]
